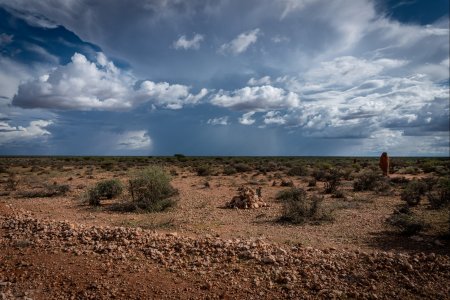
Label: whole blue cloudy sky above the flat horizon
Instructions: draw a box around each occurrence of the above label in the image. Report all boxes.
[0,0,450,156]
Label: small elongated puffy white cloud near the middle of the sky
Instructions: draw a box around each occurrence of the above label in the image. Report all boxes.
[211,85,300,111]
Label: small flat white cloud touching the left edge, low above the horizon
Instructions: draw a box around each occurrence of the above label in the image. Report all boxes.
[0,120,53,145]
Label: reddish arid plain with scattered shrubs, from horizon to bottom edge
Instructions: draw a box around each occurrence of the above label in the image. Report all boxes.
[0,155,450,299]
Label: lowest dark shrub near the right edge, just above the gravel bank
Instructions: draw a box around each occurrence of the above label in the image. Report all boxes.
[387,207,427,236]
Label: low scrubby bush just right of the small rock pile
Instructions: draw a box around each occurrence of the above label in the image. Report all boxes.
[277,188,333,224]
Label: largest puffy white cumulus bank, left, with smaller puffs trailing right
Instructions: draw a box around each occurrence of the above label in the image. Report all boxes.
[12,53,207,110]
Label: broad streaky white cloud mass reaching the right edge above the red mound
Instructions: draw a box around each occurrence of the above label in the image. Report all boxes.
[244,61,449,146]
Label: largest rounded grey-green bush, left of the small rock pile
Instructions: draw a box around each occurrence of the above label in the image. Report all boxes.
[128,166,177,212]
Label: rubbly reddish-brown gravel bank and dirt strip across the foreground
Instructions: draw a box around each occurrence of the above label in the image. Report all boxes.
[0,209,450,299]
